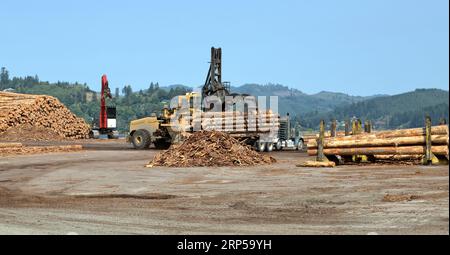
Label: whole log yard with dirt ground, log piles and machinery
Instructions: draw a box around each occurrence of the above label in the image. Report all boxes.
[0,48,449,234]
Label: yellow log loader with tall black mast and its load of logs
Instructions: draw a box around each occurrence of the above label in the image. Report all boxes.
[127,48,279,151]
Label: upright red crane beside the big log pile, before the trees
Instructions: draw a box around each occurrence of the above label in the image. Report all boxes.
[91,74,119,138]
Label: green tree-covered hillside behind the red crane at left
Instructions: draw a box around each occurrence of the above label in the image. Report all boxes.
[0,67,191,132]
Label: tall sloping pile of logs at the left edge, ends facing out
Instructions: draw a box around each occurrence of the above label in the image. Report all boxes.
[0,92,90,139]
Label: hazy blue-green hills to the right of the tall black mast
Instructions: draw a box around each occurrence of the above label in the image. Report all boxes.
[153,83,449,129]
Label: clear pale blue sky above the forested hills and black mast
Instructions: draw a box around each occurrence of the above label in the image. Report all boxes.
[0,0,449,95]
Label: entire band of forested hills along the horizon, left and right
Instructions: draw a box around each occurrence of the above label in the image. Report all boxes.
[0,68,449,131]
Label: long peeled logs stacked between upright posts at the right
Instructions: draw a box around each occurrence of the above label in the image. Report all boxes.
[307,125,449,159]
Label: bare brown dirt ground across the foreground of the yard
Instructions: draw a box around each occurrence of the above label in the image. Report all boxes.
[0,141,449,235]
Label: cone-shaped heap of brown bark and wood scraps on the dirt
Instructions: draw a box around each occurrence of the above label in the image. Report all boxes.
[147,131,276,167]
